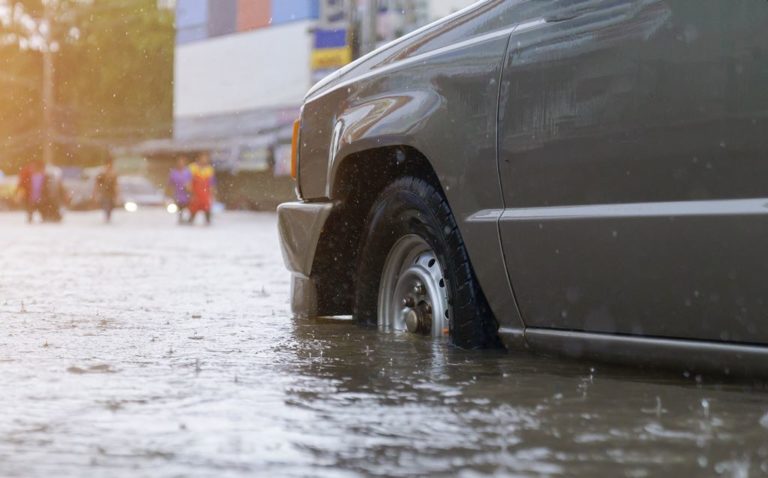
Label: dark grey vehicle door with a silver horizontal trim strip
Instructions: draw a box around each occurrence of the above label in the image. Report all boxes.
[500,0,768,343]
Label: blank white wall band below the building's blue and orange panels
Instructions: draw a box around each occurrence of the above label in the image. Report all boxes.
[174,21,313,118]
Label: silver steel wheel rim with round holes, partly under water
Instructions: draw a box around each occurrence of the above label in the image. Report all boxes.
[378,234,450,337]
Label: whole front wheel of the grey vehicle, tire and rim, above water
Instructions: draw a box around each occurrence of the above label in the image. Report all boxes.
[354,177,500,348]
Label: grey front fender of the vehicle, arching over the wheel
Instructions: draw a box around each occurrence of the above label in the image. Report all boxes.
[300,1,522,329]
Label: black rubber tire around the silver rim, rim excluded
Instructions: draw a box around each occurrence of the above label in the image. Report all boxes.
[354,177,501,349]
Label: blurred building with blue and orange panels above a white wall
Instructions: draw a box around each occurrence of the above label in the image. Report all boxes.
[174,0,319,177]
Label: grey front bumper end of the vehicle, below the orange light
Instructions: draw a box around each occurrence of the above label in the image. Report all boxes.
[277,202,333,317]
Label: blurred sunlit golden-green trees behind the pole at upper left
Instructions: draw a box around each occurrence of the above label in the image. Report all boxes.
[0,0,174,169]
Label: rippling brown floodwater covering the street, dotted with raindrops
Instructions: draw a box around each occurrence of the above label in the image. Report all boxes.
[0,212,768,477]
